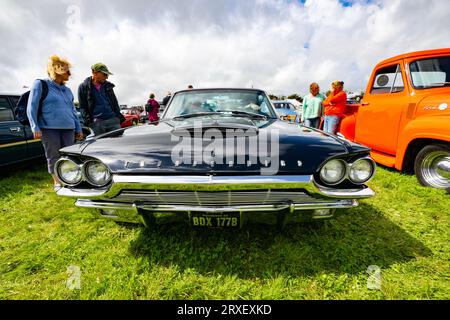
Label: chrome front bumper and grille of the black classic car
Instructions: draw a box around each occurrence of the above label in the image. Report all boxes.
[58,175,374,224]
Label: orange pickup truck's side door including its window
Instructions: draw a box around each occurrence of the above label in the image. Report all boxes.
[355,62,408,155]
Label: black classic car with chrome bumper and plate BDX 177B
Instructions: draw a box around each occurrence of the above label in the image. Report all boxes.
[56,89,375,228]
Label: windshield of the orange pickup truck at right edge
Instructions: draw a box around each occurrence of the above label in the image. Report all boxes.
[409,56,450,89]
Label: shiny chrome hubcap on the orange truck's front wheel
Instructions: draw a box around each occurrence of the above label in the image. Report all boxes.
[421,151,450,189]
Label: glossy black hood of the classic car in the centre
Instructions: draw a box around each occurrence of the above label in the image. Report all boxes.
[61,116,369,175]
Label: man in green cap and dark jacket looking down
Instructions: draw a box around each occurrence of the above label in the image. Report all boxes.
[78,62,125,135]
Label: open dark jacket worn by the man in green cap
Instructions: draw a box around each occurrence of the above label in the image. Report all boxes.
[78,77,125,127]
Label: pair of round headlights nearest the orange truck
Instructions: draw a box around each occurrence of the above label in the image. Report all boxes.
[320,158,375,185]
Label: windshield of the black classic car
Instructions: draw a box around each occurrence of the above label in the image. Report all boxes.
[164,89,276,119]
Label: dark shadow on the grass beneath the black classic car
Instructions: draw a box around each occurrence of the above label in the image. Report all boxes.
[130,204,431,279]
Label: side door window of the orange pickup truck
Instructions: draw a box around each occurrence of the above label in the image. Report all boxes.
[370,64,405,94]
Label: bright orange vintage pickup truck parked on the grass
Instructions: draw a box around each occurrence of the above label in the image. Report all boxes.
[339,48,450,191]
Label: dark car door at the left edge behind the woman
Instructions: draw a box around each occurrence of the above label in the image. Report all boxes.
[0,96,27,167]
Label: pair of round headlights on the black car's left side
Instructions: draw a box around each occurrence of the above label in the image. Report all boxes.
[55,158,111,187]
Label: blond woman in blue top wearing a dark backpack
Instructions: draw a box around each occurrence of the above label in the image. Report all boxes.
[27,55,83,189]
